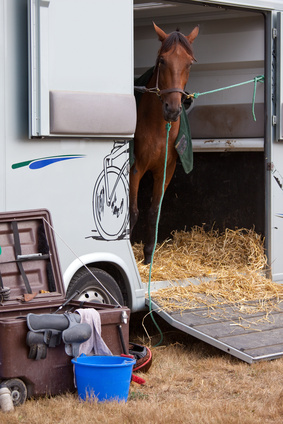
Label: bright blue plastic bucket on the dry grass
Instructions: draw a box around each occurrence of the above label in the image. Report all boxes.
[72,355,136,402]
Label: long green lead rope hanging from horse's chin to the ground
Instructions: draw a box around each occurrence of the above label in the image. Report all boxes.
[148,122,171,347]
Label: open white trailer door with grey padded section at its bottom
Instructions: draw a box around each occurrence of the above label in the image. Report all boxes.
[28,0,136,138]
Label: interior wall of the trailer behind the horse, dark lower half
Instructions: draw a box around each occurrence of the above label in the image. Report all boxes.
[134,0,265,241]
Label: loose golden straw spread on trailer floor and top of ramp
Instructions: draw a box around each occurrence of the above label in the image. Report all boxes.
[133,226,283,312]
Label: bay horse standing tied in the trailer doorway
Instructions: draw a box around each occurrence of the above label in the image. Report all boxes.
[130,23,199,264]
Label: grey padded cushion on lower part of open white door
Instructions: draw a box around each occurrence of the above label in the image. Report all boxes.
[50,91,136,138]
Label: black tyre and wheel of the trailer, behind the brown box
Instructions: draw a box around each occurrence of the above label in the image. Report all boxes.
[67,267,124,306]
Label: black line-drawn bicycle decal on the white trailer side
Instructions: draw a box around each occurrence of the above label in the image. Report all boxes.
[92,141,129,240]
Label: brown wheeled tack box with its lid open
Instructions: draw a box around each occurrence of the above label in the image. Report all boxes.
[0,209,130,405]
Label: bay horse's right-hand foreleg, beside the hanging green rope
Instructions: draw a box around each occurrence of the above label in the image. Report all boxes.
[144,163,176,264]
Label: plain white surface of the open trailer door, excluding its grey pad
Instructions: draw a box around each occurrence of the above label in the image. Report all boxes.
[29,0,133,136]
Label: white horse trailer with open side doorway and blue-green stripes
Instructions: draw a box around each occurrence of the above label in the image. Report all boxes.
[0,0,283,362]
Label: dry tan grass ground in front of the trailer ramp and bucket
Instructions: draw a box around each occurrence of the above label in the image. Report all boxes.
[0,315,283,424]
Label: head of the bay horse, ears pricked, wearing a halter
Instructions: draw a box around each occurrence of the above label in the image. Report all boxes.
[153,23,199,122]
